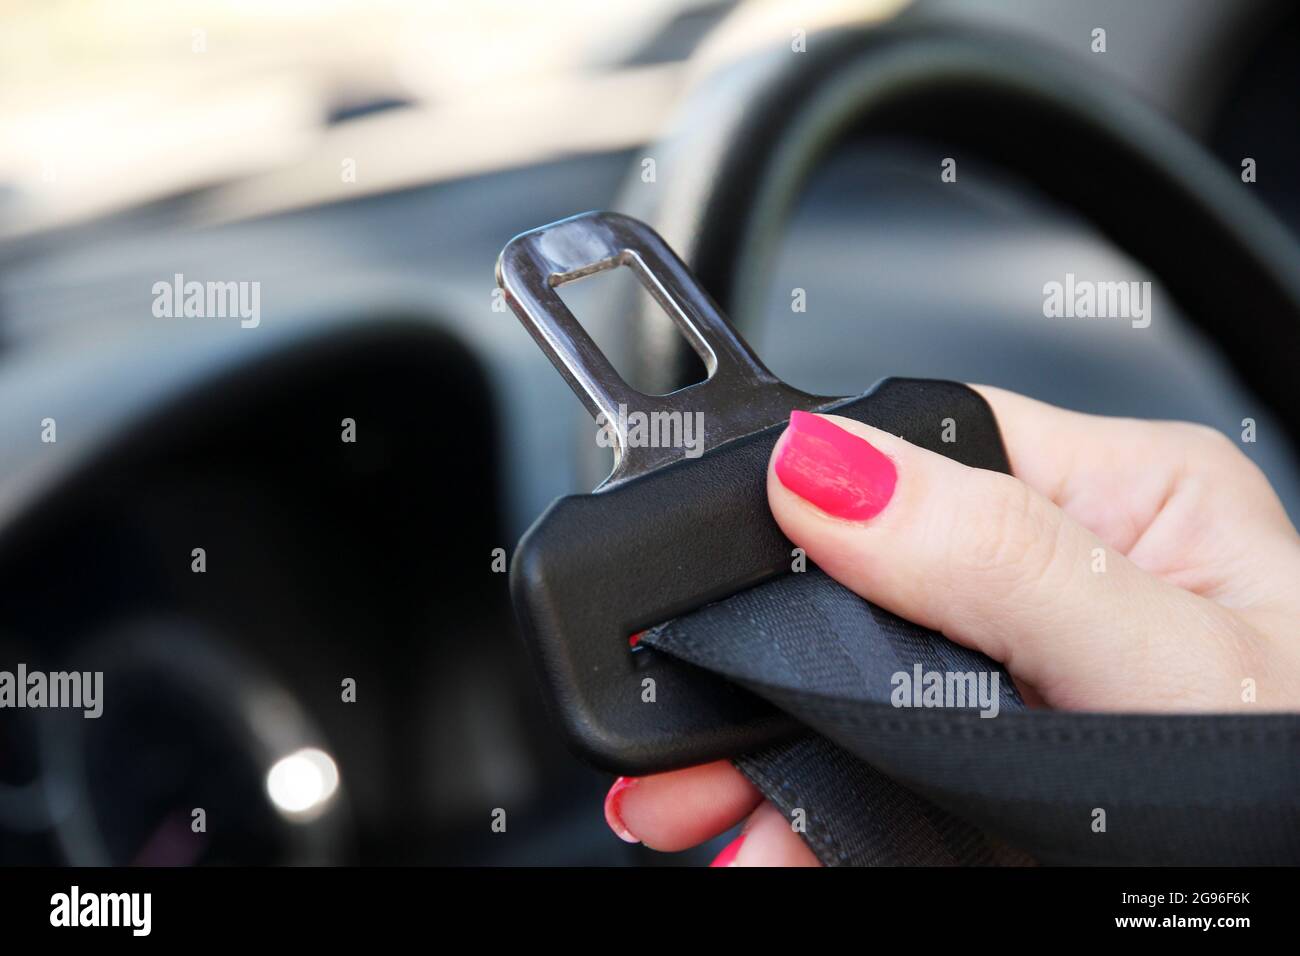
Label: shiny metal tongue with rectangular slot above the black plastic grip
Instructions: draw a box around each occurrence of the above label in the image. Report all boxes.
[497,212,836,490]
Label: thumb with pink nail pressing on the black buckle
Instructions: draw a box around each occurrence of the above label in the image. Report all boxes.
[767,412,1244,710]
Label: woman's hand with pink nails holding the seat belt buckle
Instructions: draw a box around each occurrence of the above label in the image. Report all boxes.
[605,386,1300,866]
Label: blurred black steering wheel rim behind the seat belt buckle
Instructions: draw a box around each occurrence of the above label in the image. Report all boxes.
[619,26,1300,446]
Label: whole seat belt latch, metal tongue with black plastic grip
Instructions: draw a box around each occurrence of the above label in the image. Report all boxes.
[497,212,1008,775]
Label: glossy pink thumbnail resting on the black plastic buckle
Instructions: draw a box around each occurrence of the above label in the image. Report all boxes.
[776,411,898,522]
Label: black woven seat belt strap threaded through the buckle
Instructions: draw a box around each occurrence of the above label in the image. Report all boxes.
[642,568,1300,865]
